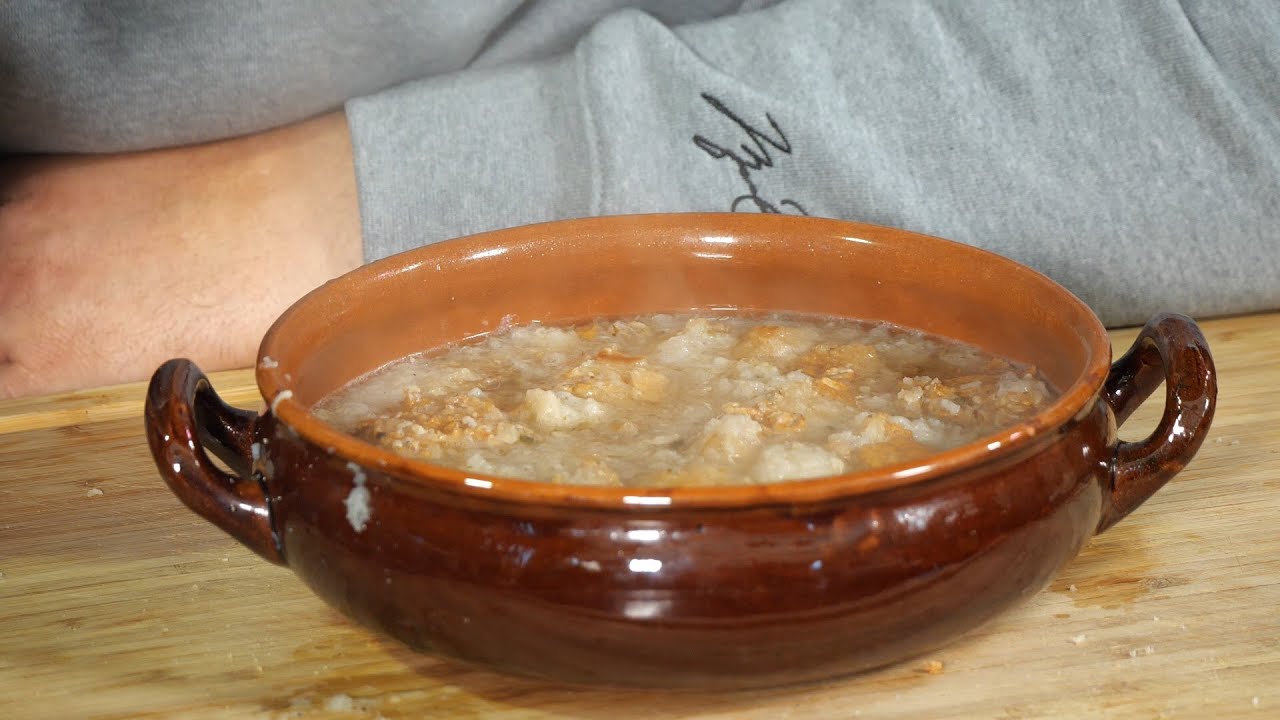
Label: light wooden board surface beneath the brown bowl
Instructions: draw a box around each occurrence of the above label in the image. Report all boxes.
[0,314,1280,720]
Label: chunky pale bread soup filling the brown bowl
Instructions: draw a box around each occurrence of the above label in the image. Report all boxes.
[316,315,1052,487]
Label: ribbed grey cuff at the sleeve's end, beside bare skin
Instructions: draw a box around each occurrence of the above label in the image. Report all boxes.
[346,55,595,261]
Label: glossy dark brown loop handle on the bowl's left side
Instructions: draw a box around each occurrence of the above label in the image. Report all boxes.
[146,359,284,565]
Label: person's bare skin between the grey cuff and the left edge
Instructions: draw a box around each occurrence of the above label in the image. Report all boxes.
[0,113,361,398]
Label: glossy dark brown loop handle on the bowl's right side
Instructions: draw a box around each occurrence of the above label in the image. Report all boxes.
[1097,313,1217,533]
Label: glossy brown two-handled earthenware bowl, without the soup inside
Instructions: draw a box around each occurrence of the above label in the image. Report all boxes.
[146,214,1216,688]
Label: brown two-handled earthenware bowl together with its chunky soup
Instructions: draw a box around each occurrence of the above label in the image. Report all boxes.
[147,214,1216,688]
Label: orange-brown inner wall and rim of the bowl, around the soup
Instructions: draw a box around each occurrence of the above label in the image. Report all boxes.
[257,214,1110,503]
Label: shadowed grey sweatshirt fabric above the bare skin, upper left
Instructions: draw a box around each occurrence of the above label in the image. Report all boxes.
[0,0,581,152]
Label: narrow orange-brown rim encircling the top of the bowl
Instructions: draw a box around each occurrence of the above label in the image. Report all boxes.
[256,213,1111,510]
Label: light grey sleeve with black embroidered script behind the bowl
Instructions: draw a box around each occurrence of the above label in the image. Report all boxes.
[347,0,1280,325]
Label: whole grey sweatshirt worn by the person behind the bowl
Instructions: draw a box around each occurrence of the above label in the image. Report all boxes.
[0,0,1280,324]
